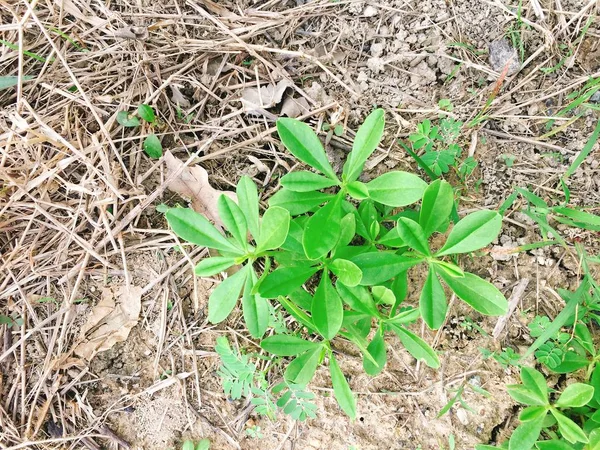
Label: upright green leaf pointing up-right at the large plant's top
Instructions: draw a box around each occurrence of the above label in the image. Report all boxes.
[344,109,385,182]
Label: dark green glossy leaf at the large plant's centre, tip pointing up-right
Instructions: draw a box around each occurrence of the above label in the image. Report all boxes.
[302,196,342,259]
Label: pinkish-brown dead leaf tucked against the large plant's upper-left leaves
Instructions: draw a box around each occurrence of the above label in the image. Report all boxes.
[164,151,237,227]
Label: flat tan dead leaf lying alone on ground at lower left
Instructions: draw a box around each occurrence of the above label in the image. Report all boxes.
[74,286,142,361]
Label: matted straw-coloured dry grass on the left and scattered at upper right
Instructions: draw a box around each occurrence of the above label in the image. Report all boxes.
[0,0,600,449]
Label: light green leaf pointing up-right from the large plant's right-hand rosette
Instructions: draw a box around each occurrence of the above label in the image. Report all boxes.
[436,210,502,256]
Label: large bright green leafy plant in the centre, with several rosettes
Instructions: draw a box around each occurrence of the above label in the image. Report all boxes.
[165,109,507,418]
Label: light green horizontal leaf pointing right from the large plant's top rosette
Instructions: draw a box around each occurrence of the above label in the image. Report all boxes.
[367,171,427,207]
